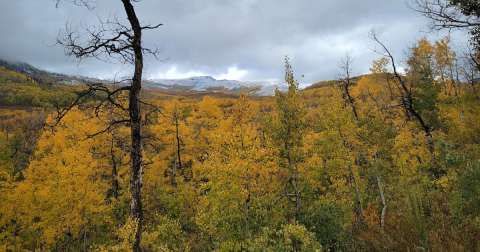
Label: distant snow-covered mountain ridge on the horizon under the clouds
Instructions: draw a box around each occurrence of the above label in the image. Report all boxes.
[142,76,288,96]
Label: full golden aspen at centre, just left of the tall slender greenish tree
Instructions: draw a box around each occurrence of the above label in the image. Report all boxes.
[197,94,284,250]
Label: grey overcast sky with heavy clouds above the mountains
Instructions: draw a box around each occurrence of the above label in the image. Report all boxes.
[0,0,463,85]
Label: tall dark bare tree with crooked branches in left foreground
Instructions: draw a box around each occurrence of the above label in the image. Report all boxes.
[54,0,161,251]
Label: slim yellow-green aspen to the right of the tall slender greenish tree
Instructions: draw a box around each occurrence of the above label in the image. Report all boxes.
[315,86,364,215]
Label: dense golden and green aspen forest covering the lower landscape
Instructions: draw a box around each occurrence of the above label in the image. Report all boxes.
[0,38,480,251]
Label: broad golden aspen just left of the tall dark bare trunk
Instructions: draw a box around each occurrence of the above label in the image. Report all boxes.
[4,110,120,250]
